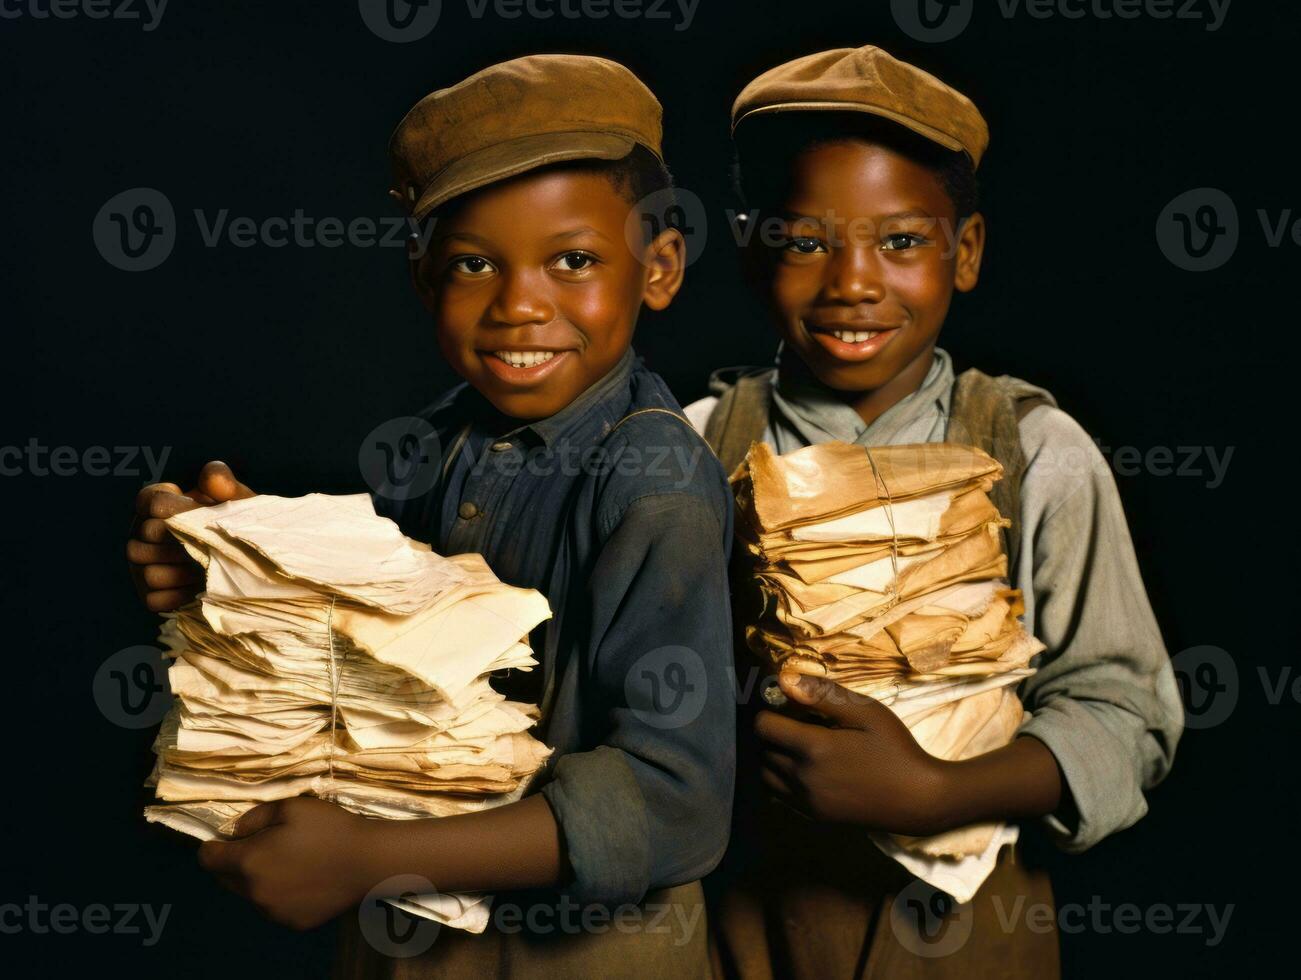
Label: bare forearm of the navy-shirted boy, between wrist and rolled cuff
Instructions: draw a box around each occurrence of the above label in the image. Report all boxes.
[354,795,566,892]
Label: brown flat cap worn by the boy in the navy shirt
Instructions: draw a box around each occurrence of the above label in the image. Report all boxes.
[389,55,662,219]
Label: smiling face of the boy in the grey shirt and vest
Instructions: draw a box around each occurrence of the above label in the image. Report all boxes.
[756,139,984,422]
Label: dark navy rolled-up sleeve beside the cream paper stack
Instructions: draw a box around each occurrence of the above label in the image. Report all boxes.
[543,488,736,905]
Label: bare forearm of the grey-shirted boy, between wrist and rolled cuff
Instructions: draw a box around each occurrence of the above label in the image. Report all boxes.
[934,737,1066,833]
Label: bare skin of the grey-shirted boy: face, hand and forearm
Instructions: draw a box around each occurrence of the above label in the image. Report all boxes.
[748,139,1069,837]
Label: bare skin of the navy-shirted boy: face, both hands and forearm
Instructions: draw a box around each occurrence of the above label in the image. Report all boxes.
[127,168,686,929]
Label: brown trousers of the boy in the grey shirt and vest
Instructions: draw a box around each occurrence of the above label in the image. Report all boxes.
[706,806,1060,980]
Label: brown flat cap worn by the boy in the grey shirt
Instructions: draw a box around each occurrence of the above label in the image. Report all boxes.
[732,44,989,167]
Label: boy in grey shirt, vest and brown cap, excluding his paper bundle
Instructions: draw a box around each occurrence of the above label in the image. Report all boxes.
[686,47,1183,977]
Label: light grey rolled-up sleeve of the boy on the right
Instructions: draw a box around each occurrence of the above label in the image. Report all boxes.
[1017,406,1183,851]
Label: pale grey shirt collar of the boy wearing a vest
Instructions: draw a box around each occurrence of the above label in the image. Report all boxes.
[773,345,954,444]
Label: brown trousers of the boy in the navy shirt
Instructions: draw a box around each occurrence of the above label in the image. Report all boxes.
[334,881,709,980]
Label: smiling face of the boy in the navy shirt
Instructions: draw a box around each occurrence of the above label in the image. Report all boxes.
[412,168,683,419]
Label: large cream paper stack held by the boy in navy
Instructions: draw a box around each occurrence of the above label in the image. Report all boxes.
[146,495,550,931]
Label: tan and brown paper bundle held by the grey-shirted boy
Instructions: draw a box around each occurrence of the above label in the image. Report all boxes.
[732,442,1043,858]
